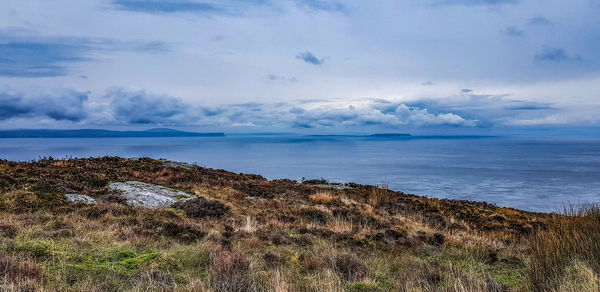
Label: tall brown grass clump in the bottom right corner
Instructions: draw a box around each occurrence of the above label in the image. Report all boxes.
[528,205,600,291]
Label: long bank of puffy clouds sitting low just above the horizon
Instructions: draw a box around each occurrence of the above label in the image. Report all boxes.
[0,88,576,129]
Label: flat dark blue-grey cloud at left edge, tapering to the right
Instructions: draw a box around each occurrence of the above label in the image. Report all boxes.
[0,30,169,77]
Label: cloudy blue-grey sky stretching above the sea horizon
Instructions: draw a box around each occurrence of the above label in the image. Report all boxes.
[0,0,600,133]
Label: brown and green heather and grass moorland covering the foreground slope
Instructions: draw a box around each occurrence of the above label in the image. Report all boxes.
[0,157,600,291]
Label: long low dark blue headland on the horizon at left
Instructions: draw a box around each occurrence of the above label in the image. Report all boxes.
[0,128,225,138]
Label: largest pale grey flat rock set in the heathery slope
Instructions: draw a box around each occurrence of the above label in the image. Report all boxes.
[108,181,195,208]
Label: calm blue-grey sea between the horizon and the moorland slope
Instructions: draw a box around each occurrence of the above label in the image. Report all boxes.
[0,136,600,211]
